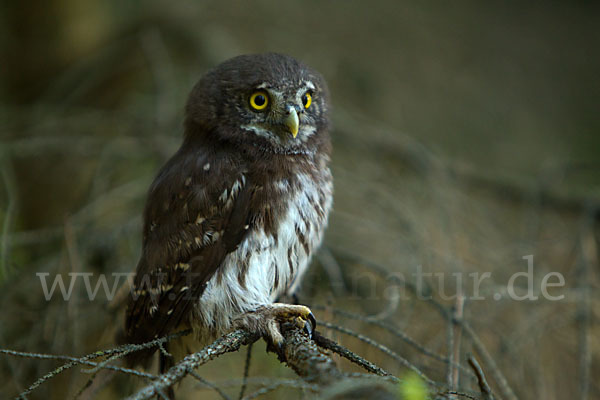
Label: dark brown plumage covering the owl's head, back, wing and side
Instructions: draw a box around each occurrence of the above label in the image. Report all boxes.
[119,54,331,364]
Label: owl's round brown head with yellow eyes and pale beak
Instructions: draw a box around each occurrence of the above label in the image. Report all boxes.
[186,53,328,153]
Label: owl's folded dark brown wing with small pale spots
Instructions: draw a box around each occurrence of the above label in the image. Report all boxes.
[125,150,252,362]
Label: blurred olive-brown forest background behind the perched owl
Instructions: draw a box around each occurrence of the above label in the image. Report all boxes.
[0,0,600,399]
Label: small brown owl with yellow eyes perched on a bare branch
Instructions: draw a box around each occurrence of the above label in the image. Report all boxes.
[124,54,333,364]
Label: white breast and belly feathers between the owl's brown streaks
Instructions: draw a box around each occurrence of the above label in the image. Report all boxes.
[194,172,332,334]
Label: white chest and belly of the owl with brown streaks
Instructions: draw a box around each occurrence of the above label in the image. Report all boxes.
[200,171,332,325]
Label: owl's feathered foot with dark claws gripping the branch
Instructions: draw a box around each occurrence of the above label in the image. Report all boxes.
[233,303,317,353]
